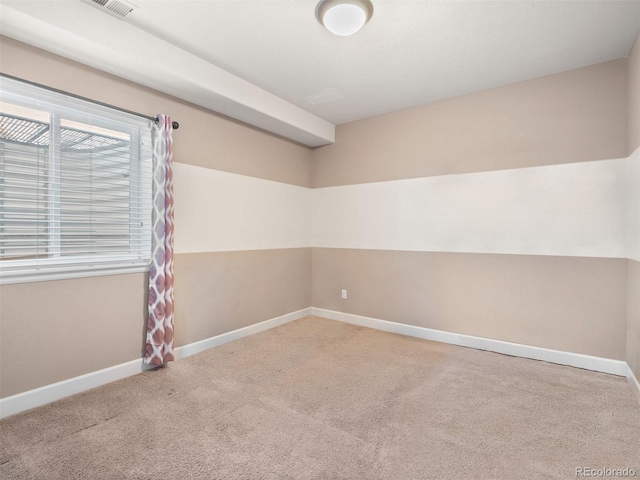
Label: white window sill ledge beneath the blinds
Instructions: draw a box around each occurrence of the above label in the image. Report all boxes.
[0,263,149,285]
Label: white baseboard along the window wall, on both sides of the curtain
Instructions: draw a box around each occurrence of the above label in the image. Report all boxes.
[0,308,311,418]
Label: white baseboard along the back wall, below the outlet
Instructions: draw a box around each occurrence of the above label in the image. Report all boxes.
[311,307,630,377]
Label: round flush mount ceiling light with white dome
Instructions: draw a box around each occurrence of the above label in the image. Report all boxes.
[316,0,373,37]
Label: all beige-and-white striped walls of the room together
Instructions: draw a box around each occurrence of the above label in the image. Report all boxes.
[0,33,640,398]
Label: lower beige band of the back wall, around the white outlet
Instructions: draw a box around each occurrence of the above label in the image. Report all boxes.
[312,248,627,360]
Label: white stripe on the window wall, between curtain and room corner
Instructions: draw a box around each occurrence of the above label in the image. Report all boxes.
[174,163,311,254]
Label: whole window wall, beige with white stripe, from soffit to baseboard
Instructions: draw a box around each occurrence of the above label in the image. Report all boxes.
[0,37,311,398]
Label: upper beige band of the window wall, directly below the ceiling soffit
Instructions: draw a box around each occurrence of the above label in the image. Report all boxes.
[0,37,311,186]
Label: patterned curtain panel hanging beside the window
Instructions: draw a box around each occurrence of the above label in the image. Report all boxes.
[144,115,174,365]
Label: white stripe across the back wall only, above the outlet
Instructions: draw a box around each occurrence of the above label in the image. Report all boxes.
[312,159,627,258]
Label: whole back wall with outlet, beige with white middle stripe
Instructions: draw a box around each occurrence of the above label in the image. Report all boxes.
[312,59,628,360]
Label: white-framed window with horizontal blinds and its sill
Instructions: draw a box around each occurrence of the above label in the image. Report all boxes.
[0,78,151,283]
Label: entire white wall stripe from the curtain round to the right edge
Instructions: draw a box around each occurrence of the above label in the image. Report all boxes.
[175,155,640,261]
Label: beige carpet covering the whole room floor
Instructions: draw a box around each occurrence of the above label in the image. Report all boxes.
[0,317,640,480]
